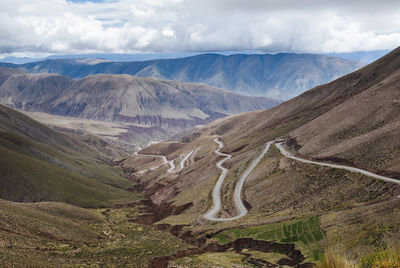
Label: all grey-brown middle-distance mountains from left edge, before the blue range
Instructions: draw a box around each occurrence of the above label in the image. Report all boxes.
[0,68,278,129]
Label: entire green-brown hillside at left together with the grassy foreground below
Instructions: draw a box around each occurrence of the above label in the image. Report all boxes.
[0,101,197,268]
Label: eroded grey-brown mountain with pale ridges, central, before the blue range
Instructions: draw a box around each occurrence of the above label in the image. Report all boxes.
[48,75,277,128]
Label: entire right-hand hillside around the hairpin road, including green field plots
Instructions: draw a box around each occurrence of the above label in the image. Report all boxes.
[120,48,400,267]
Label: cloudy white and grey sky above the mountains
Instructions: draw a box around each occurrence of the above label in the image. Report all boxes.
[0,0,400,57]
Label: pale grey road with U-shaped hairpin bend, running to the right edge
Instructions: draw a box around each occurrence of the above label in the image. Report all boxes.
[203,138,400,222]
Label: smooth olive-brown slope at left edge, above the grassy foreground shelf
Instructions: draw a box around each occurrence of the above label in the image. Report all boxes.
[0,103,138,207]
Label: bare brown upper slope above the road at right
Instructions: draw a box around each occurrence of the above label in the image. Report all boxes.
[217,45,400,171]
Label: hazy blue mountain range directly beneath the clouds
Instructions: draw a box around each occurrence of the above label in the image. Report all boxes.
[0,53,364,100]
